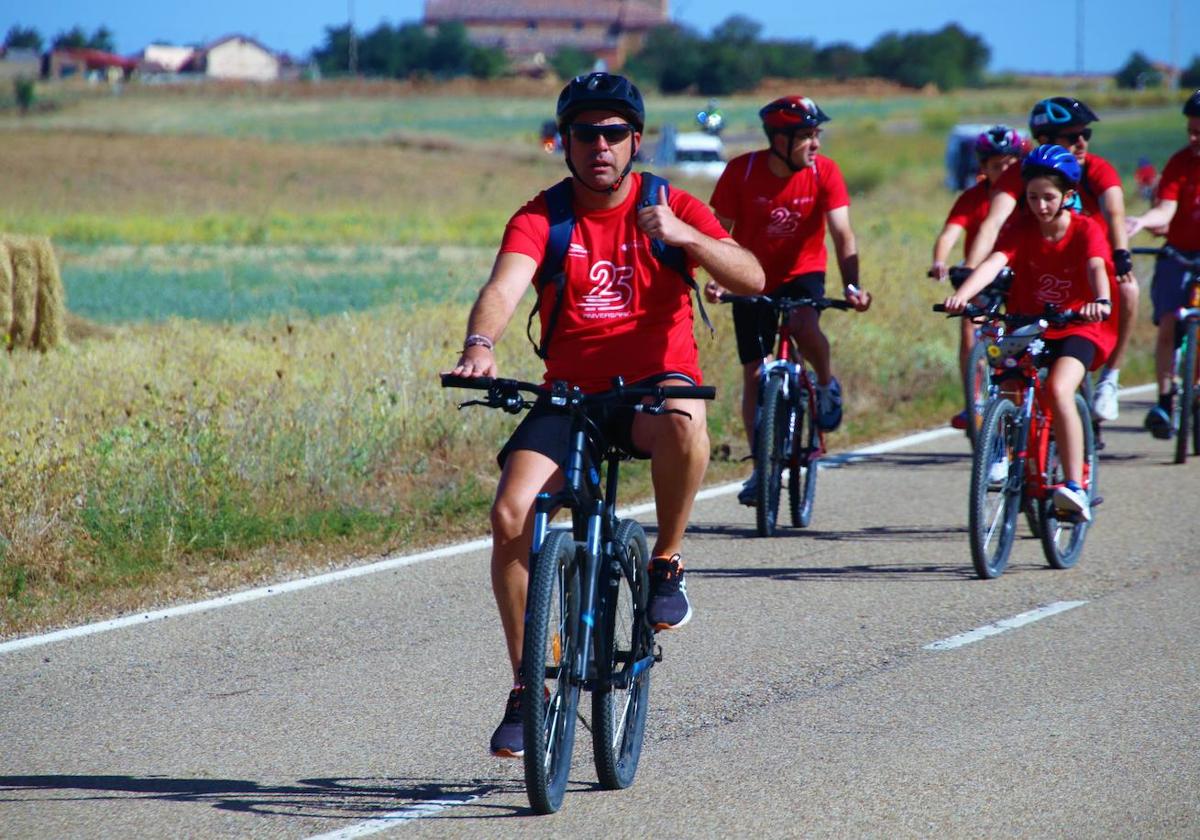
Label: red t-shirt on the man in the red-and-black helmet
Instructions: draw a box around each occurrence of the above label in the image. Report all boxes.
[710,151,850,293]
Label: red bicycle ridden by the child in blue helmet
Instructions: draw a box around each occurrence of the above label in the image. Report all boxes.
[934,304,1103,580]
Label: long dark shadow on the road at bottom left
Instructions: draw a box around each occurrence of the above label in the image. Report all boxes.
[0,774,528,827]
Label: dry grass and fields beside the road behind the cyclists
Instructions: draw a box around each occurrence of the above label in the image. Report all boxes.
[0,85,1183,635]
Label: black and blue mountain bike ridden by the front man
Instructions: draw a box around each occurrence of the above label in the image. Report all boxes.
[442,374,716,814]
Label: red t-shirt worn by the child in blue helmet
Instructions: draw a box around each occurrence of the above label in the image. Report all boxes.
[996,214,1120,368]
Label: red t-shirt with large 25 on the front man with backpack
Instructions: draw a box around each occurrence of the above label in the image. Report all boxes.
[500,173,728,394]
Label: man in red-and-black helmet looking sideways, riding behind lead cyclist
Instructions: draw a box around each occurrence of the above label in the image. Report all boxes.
[706,96,871,504]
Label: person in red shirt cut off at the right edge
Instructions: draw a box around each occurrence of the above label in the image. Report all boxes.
[1127,90,1200,438]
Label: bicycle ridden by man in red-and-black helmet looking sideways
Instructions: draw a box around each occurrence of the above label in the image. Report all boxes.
[720,293,853,536]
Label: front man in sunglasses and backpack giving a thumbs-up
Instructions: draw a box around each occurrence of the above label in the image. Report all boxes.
[452,73,763,757]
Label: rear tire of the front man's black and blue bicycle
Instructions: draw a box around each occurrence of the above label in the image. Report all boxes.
[592,520,654,791]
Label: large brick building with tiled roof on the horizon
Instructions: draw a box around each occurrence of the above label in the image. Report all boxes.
[425,0,670,70]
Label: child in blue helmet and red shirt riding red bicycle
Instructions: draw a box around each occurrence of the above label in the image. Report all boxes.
[946,144,1116,521]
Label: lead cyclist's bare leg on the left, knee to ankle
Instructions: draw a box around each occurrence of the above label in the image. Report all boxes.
[492,449,563,684]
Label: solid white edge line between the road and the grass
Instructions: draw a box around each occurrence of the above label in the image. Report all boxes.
[0,383,1156,654]
